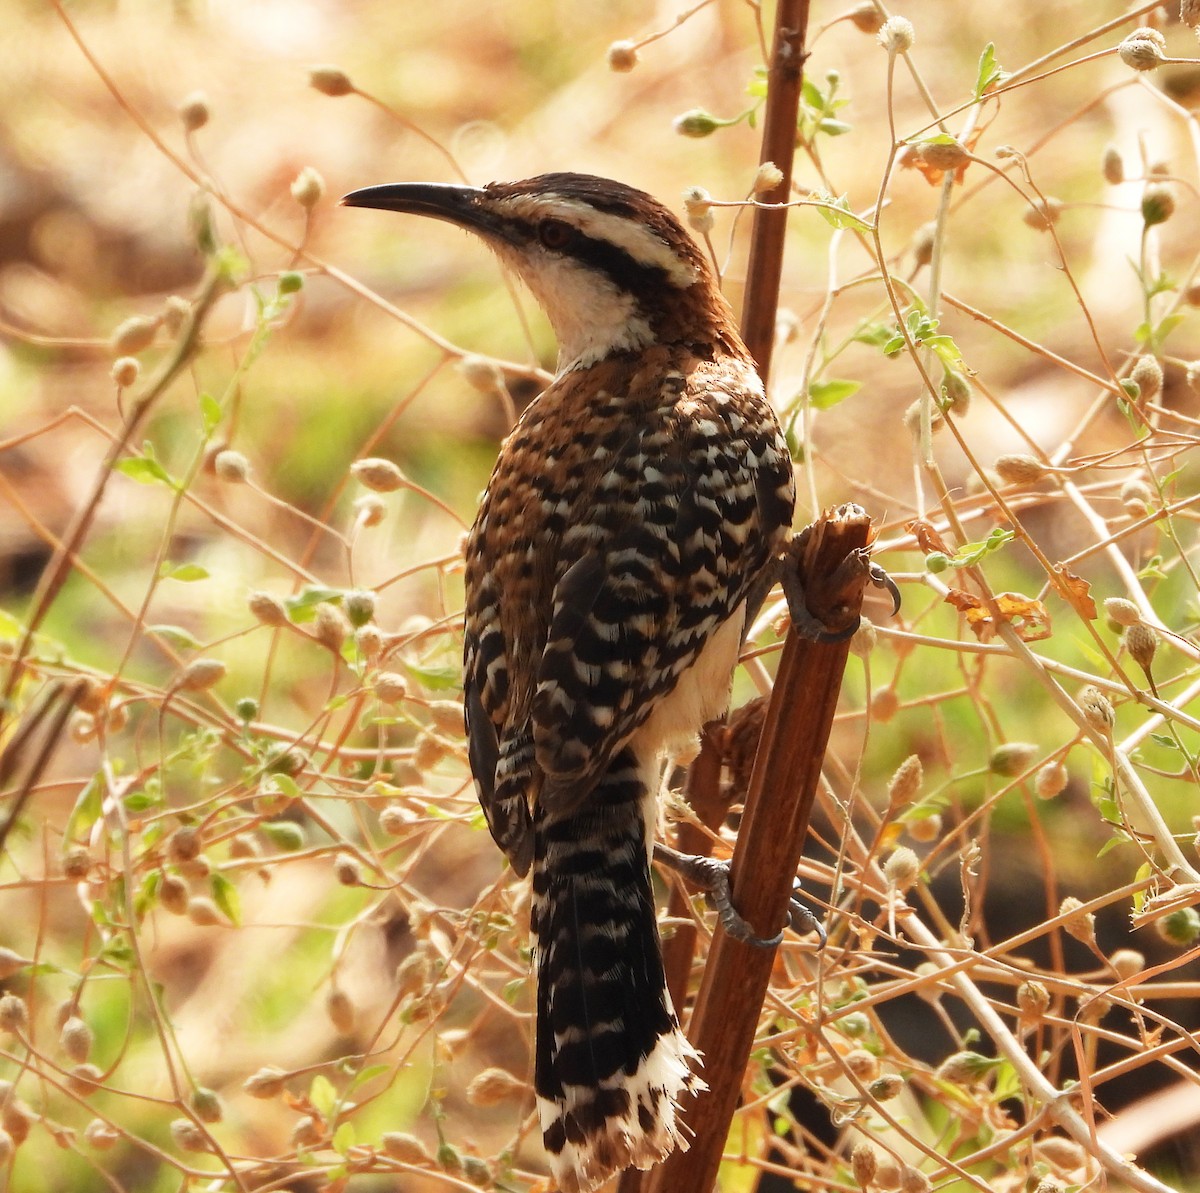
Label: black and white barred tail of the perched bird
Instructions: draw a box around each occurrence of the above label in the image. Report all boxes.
[533,747,704,1193]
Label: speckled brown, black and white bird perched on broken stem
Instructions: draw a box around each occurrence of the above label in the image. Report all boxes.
[344,174,796,1193]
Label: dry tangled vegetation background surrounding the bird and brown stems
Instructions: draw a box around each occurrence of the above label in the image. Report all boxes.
[0,0,1200,1193]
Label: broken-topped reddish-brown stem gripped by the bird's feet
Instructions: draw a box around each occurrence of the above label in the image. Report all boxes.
[644,505,870,1193]
